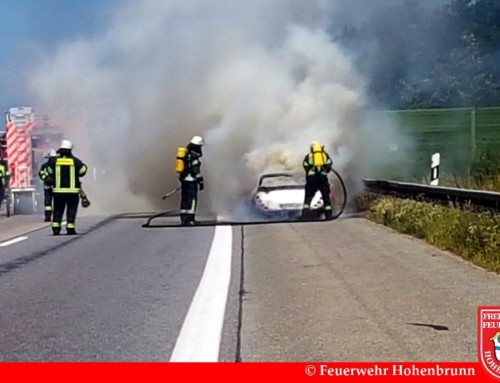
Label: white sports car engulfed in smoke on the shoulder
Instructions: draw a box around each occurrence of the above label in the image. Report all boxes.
[251,173,323,218]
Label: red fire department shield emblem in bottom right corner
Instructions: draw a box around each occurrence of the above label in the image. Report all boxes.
[477,306,500,379]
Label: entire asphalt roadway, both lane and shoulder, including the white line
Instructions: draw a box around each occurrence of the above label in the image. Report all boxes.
[0,217,500,361]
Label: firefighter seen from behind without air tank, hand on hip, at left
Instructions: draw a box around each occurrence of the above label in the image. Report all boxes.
[47,140,87,235]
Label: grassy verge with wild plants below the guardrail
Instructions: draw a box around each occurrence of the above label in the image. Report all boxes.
[367,197,500,273]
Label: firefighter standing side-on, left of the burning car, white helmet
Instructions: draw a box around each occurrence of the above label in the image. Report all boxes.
[179,136,205,226]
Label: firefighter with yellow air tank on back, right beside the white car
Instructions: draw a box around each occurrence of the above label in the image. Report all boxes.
[302,141,333,219]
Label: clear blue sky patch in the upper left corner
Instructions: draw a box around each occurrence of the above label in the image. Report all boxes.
[0,0,121,110]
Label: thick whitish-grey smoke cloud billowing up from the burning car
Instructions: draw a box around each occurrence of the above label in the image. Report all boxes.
[31,0,376,213]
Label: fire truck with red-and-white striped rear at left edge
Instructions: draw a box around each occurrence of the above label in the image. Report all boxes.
[0,107,63,214]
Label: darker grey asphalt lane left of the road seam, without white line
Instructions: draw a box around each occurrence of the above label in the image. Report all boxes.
[0,218,239,361]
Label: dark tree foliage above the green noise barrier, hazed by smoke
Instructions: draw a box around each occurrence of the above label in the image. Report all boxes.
[339,0,500,108]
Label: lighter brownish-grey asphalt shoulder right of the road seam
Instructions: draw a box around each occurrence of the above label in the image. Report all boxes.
[241,218,500,361]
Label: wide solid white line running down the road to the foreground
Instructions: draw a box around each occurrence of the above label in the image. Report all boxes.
[170,226,233,362]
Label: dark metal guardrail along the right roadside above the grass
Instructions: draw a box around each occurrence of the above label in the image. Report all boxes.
[363,179,500,210]
